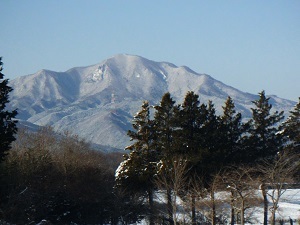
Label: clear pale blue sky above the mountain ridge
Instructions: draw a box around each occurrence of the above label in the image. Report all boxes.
[0,0,300,101]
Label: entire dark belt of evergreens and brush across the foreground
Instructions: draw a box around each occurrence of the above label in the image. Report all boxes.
[0,60,300,225]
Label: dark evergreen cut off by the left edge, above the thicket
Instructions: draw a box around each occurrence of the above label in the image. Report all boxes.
[0,57,17,160]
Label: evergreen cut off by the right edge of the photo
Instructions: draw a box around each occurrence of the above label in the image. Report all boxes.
[283,98,300,152]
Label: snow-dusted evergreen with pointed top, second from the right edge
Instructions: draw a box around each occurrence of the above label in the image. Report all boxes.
[243,91,284,163]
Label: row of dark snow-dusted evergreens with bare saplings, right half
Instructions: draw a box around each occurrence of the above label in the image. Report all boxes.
[116,91,300,225]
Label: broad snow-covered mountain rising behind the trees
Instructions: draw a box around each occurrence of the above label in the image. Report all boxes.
[10,54,295,149]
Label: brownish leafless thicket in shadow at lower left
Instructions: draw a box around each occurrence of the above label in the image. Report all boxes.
[0,127,131,224]
